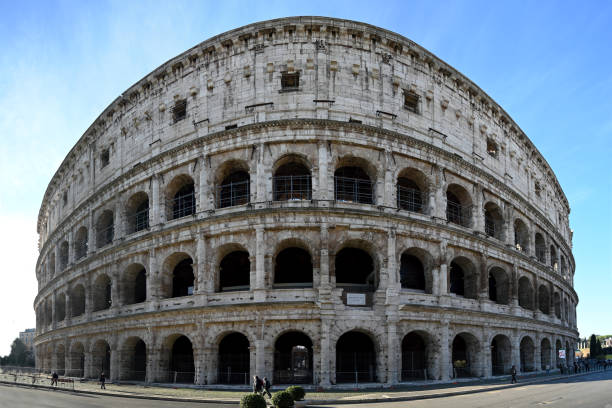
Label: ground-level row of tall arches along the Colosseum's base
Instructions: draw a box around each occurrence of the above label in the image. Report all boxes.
[41,329,572,384]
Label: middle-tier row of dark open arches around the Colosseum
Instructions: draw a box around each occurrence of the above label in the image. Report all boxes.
[37,240,569,326]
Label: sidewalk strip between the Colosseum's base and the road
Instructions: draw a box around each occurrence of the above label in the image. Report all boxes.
[0,370,601,405]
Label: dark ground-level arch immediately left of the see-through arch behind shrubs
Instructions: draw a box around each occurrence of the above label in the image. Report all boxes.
[217,333,250,384]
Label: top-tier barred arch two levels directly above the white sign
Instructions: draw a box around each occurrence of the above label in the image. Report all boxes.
[334,166,374,204]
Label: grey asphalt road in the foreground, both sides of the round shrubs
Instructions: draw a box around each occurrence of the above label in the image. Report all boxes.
[0,370,612,408]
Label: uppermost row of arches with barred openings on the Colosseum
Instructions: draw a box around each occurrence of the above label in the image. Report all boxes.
[45,155,567,277]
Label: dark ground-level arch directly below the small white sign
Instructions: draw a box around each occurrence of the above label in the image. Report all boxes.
[336,330,376,384]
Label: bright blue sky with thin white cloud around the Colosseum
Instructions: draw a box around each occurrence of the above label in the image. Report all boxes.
[0,0,612,355]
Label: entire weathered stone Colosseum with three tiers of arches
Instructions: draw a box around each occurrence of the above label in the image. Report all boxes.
[34,17,578,387]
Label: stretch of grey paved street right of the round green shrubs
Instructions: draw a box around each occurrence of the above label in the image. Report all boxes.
[316,370,612,408]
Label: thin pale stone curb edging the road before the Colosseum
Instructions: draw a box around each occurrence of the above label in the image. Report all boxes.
[0,370,603,406]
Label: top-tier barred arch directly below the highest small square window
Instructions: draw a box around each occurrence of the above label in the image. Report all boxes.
[272,159,312,201]
